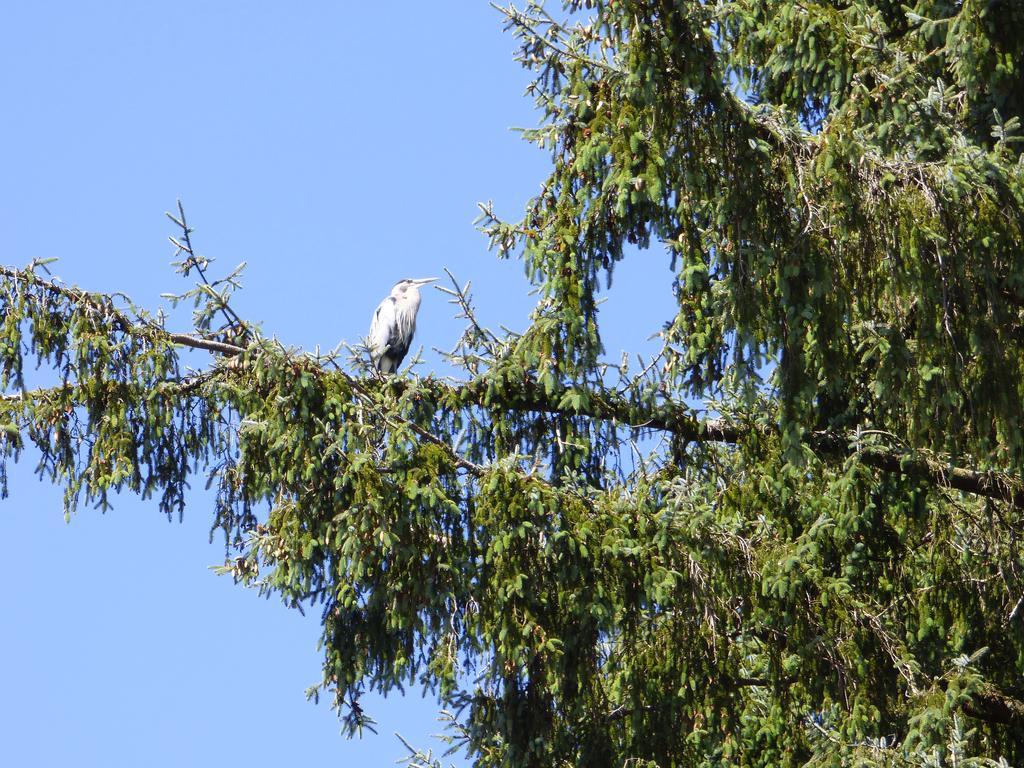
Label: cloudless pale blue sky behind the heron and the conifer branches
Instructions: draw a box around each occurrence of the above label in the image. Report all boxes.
[0,0,671,768]
